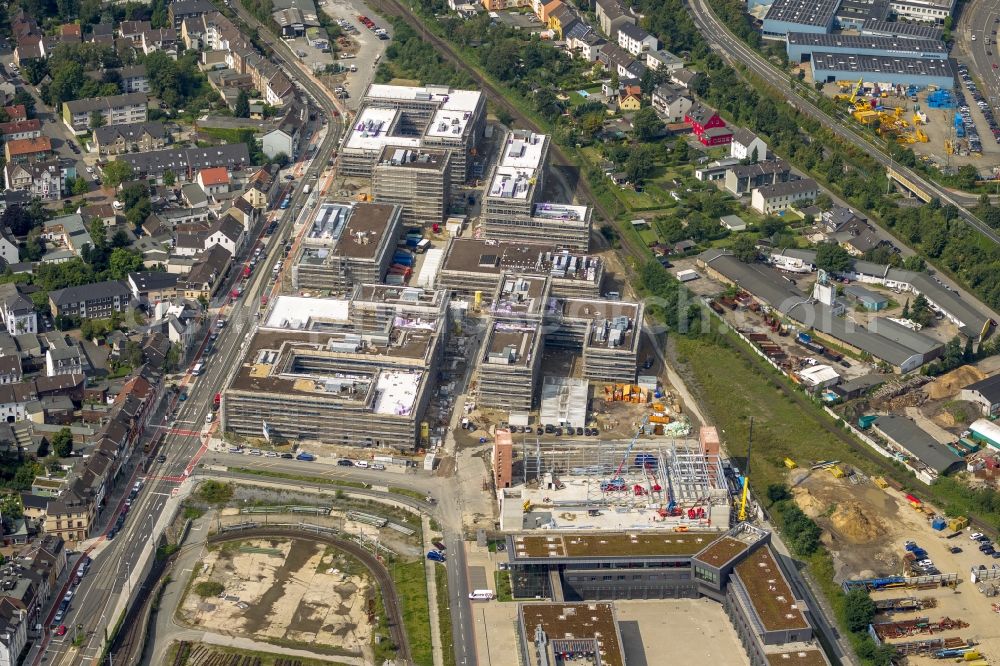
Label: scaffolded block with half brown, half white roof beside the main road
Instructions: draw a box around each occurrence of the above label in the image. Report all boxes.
[292,203,402,294]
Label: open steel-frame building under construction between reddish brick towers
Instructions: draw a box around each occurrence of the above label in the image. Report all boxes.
[496,423,739,532]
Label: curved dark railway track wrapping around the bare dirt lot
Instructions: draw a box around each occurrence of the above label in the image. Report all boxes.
[207,527,413,665]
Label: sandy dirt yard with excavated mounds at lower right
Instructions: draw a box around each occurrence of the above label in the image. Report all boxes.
[790,470,1000,664]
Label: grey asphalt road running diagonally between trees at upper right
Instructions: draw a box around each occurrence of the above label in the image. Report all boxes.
[688,0,1000,244]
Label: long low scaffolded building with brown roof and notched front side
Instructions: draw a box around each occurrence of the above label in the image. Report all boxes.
[436,238,604,298]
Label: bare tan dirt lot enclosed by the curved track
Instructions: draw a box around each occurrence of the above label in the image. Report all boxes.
[179,540,373,660]
